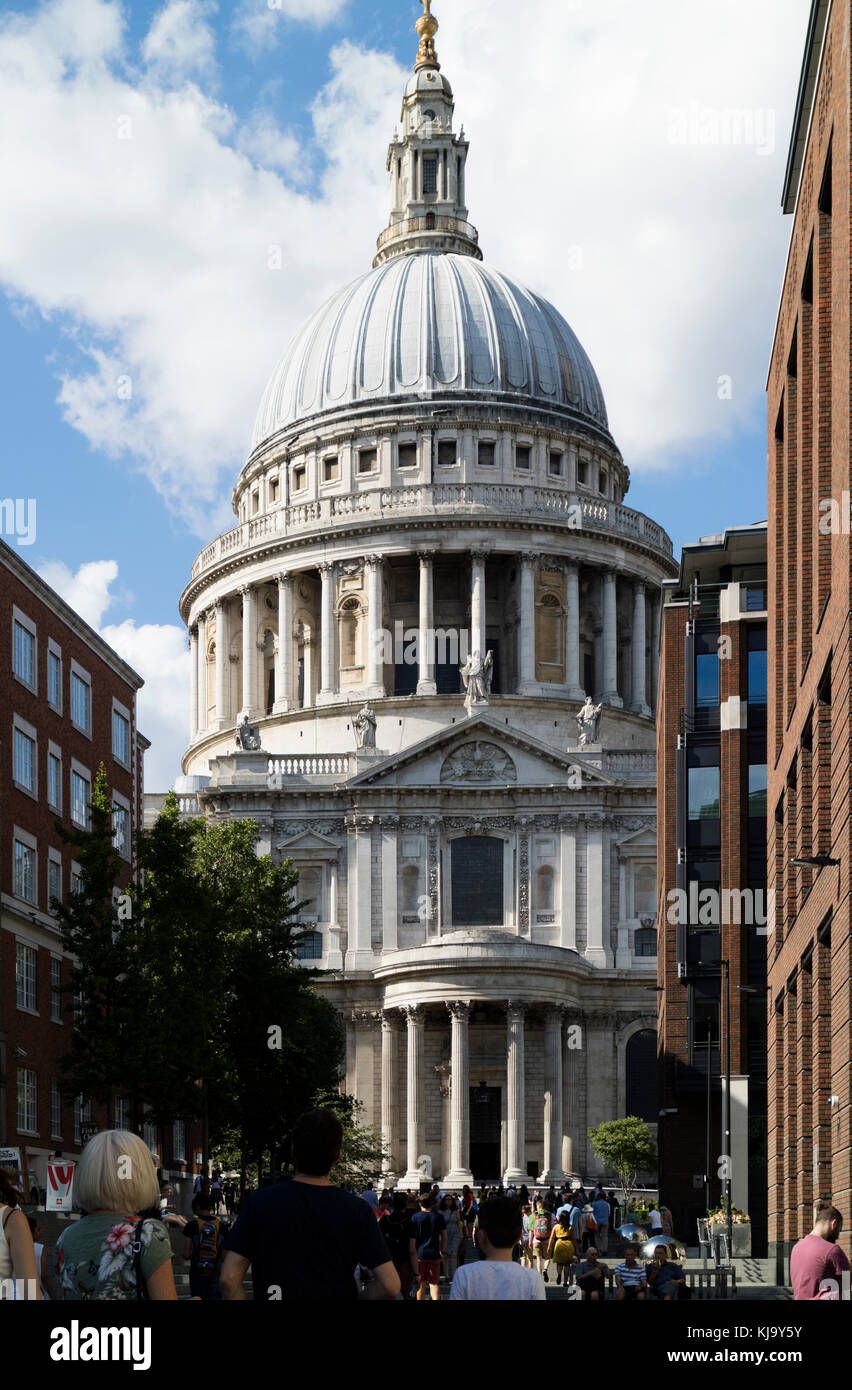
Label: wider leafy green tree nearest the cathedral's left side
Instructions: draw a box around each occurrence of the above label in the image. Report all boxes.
[140,795,343,1166]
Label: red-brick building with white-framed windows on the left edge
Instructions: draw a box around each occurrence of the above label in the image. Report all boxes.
[0,541,195,1187]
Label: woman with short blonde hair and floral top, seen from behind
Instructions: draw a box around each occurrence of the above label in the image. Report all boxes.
[54,1130,178,1300]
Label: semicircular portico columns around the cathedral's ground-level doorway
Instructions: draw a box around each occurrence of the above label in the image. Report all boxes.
[355,999,592,1188]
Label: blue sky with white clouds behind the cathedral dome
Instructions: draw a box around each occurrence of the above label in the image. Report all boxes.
[0,0,809,790]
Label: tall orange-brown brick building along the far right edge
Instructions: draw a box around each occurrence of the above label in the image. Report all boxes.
[767,0,852,1277]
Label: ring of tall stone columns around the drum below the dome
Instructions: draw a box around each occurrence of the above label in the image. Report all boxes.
[189,549,660,742]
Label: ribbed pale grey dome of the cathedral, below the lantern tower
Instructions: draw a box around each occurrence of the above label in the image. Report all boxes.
[252,252,609,450]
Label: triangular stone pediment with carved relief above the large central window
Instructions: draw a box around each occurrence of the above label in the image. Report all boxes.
[346,714,617,788]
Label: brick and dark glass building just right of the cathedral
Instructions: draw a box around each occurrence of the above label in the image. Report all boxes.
[657,523,771,1254]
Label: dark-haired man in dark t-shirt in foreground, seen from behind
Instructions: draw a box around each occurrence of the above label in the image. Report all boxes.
[220,1109,400,1302]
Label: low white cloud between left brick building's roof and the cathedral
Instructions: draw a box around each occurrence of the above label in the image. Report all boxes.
[39,560,189,791]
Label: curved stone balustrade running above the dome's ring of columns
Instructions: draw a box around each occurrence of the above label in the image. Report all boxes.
[192,482,671,580]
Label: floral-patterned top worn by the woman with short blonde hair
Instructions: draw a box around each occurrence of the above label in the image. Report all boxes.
[54,1212,171,1300]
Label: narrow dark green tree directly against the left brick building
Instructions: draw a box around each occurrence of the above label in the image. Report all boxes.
[51,763,153,1125]
